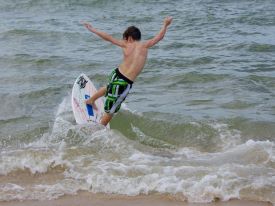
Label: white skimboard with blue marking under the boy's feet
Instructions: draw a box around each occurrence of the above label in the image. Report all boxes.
[72,74,109,127]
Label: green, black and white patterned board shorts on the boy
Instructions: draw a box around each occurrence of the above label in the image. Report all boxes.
[104,68,133,114]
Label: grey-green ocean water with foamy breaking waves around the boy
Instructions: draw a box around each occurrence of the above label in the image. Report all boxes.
[0,0,275,203]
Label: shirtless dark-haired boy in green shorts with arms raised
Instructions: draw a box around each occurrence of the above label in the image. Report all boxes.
[84,17,172,126]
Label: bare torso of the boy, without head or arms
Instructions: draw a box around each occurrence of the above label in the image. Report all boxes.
[119,41,148,81]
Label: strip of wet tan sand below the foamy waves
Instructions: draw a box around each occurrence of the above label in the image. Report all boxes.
[0,192,272,206]
